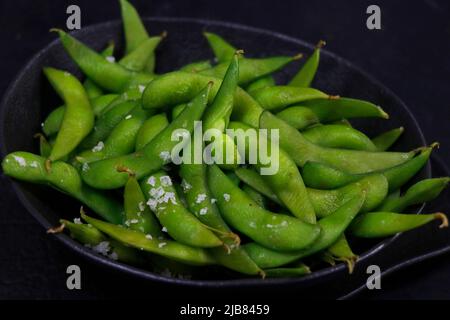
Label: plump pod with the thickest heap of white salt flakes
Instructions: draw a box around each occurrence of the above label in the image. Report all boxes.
[141,171,222,248]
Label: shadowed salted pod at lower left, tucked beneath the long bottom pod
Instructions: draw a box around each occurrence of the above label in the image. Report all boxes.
[59,219,144,265]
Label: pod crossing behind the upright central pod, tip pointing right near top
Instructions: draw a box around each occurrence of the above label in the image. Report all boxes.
[200,55,301,85]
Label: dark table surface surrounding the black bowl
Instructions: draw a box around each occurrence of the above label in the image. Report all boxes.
[0,0,450,299]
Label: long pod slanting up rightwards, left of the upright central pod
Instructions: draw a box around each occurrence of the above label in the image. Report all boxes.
[82,83,212,189]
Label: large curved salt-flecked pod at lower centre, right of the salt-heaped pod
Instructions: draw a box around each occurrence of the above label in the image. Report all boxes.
[208,166,320,250]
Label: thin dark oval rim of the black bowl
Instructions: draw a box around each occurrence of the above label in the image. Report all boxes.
[0,16,431,288]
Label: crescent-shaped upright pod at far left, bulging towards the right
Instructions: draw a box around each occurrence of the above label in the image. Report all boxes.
[44,68,94,161]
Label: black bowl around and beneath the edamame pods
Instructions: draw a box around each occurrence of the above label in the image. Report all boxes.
[0,18,431,288]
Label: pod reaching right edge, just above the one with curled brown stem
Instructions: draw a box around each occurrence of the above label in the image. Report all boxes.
[377,177,450,212]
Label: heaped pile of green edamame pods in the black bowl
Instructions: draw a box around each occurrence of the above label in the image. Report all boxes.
[2,0,449,277]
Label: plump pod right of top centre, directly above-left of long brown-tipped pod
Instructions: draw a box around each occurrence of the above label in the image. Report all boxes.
[251,86,330,111]
